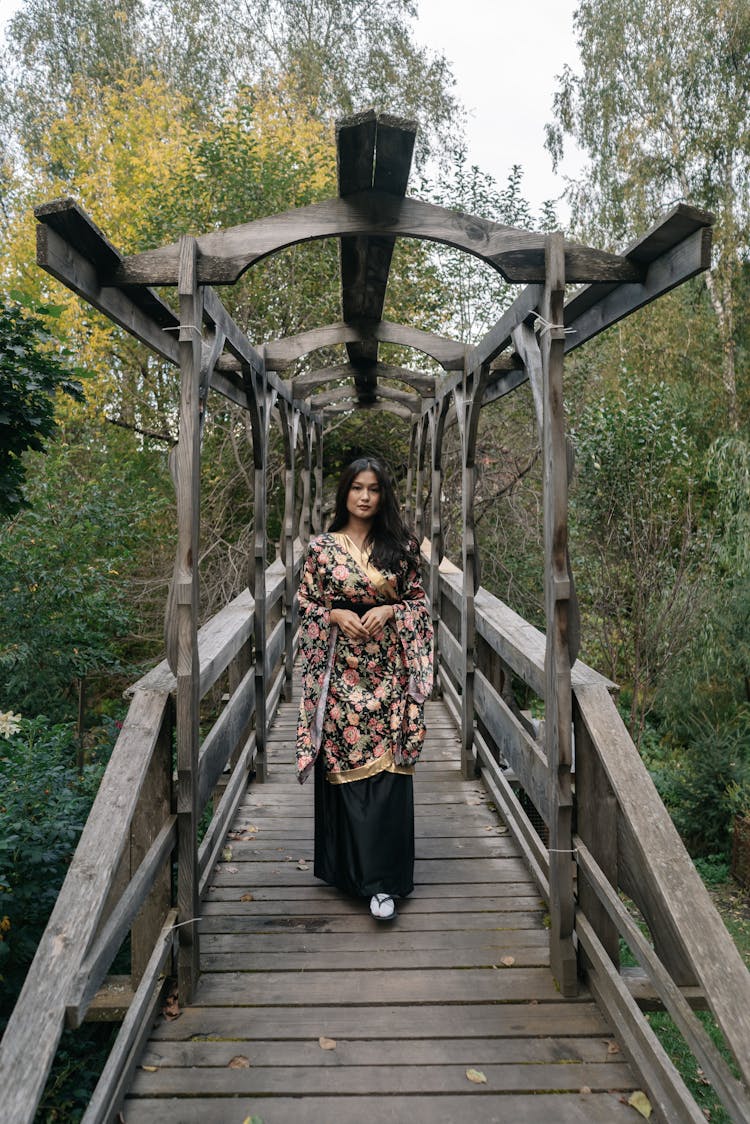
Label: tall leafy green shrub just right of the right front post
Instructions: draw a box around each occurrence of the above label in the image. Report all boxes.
[571,382,703,741]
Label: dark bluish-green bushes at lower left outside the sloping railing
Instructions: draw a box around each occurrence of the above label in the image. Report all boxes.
[0,717,115,1019]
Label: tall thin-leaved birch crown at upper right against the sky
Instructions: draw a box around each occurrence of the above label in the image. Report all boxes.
[546,0,750,429]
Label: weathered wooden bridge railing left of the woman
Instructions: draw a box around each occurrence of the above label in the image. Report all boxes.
[0,542,301,1124]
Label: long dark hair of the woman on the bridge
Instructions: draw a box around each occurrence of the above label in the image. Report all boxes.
[328,456,419,571]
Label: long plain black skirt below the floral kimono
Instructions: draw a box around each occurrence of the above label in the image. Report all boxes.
[314,758,414,898]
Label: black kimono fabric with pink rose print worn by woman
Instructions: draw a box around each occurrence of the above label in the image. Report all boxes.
[297,534,433,783]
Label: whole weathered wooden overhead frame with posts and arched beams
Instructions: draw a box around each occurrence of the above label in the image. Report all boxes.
[36,111,712,994]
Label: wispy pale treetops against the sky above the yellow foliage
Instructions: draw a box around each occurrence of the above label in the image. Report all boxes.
[1,0,461,160]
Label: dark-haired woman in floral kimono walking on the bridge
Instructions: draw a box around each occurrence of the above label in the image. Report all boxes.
[297,457,432,921]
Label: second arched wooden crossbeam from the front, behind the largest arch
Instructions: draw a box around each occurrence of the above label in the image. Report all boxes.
[263,320,466,371]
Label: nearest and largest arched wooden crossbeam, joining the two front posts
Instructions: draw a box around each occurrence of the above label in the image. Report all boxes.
[111,189,643,284]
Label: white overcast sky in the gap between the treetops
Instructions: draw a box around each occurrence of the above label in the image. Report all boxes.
[0,0,582,218]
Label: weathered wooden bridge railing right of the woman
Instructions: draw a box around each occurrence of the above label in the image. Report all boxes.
[431,562,750,1124]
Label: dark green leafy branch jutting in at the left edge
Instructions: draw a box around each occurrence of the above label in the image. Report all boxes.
[0,302,83,517]
